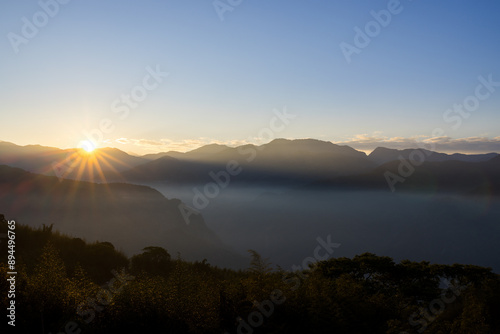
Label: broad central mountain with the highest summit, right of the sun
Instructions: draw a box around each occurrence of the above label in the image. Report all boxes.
[115,139,375,183]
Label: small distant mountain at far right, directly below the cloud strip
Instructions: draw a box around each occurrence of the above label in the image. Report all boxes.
[368,147,498,165]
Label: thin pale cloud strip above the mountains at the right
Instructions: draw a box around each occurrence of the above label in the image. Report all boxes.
[333,133,500,154]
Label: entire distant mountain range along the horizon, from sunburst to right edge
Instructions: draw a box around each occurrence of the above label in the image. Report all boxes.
[0,139,499,193]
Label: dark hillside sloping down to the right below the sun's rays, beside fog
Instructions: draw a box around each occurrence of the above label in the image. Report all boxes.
[0,165,244,267]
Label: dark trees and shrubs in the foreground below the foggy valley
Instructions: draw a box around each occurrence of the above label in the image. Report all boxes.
[0,215,500,334]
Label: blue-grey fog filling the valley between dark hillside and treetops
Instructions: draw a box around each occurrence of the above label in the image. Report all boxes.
[147,183,500,272]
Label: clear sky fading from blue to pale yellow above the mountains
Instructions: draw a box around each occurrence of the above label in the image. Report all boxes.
[0,0,500,153]
